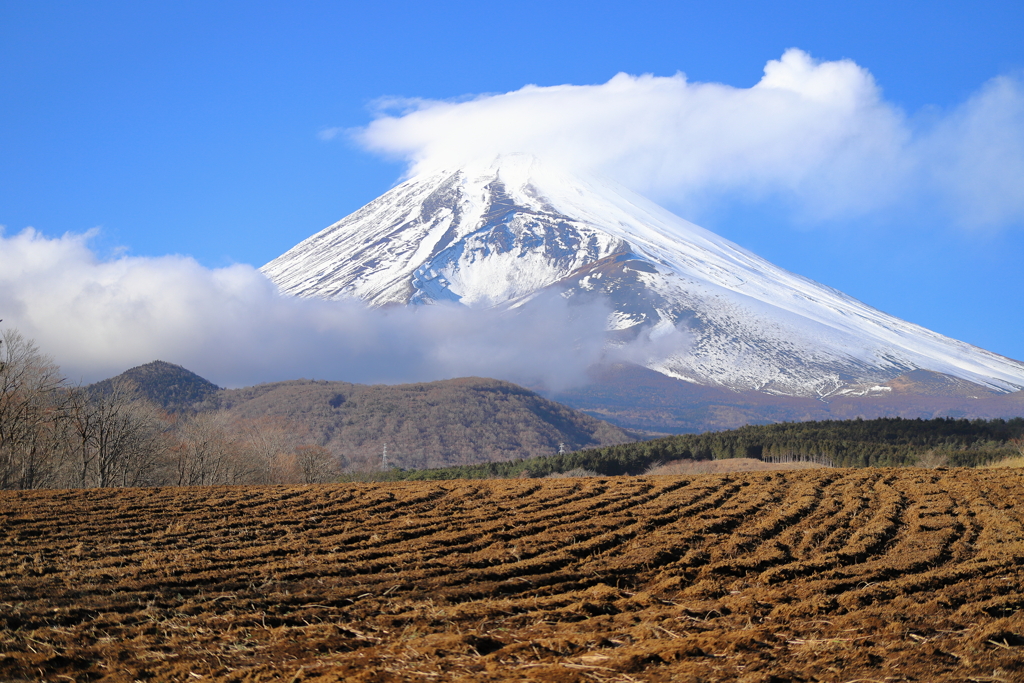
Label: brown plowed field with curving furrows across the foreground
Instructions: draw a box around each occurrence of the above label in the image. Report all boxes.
[0,469,1024,683]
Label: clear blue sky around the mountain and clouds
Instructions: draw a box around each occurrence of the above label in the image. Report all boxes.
[0,0,1024,379]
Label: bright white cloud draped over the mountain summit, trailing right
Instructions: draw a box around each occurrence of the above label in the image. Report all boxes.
[355,49,1024,229]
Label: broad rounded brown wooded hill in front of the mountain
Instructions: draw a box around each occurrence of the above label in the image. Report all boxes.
[219,377,635,469]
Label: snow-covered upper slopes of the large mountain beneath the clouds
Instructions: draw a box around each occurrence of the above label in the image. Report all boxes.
[262,155,1024,397]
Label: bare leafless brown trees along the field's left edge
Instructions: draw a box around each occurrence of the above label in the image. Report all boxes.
[0,329,338,489]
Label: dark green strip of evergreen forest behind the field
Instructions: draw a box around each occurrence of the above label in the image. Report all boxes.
[378,418,1024,479]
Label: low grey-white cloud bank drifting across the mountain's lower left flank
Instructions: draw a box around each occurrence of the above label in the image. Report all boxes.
[0,229,667,388]
